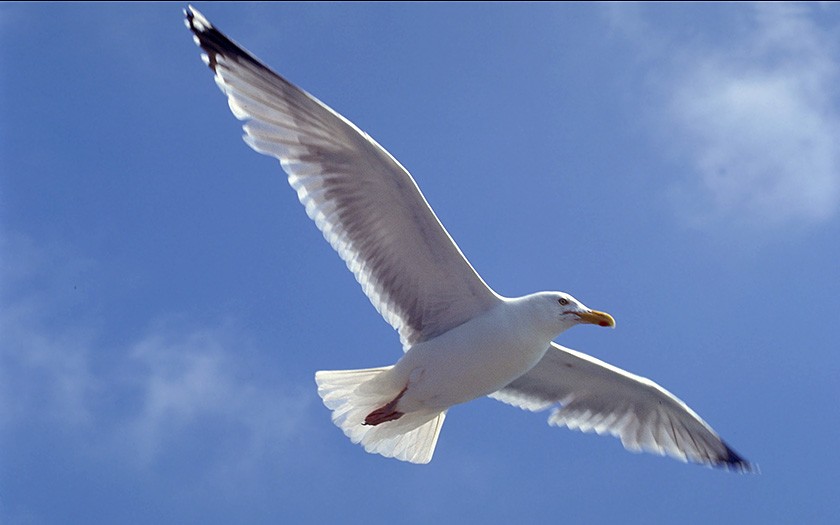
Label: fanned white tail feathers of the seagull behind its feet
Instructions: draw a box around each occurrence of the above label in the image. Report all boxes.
[315,366,446,463]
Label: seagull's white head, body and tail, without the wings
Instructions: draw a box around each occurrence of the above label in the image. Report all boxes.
[315,292,614,463]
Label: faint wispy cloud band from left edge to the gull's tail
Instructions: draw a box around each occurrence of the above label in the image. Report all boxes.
[0,234,314,470]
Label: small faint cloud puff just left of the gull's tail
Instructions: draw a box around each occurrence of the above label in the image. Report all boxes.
[119,325,313,463]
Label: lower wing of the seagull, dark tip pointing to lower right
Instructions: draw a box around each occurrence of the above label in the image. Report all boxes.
[490,343,753,471]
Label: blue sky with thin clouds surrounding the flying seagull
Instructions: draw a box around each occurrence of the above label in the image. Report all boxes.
[0,3,840,524]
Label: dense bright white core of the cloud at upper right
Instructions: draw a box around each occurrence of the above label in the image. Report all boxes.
[672,62,840,226]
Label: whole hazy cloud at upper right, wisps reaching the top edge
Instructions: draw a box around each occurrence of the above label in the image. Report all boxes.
[613,5,840,230]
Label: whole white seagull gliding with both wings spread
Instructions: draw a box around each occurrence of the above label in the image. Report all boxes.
[184,6,754,472]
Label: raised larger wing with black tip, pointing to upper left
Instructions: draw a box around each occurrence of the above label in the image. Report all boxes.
[185,7,499,348]
